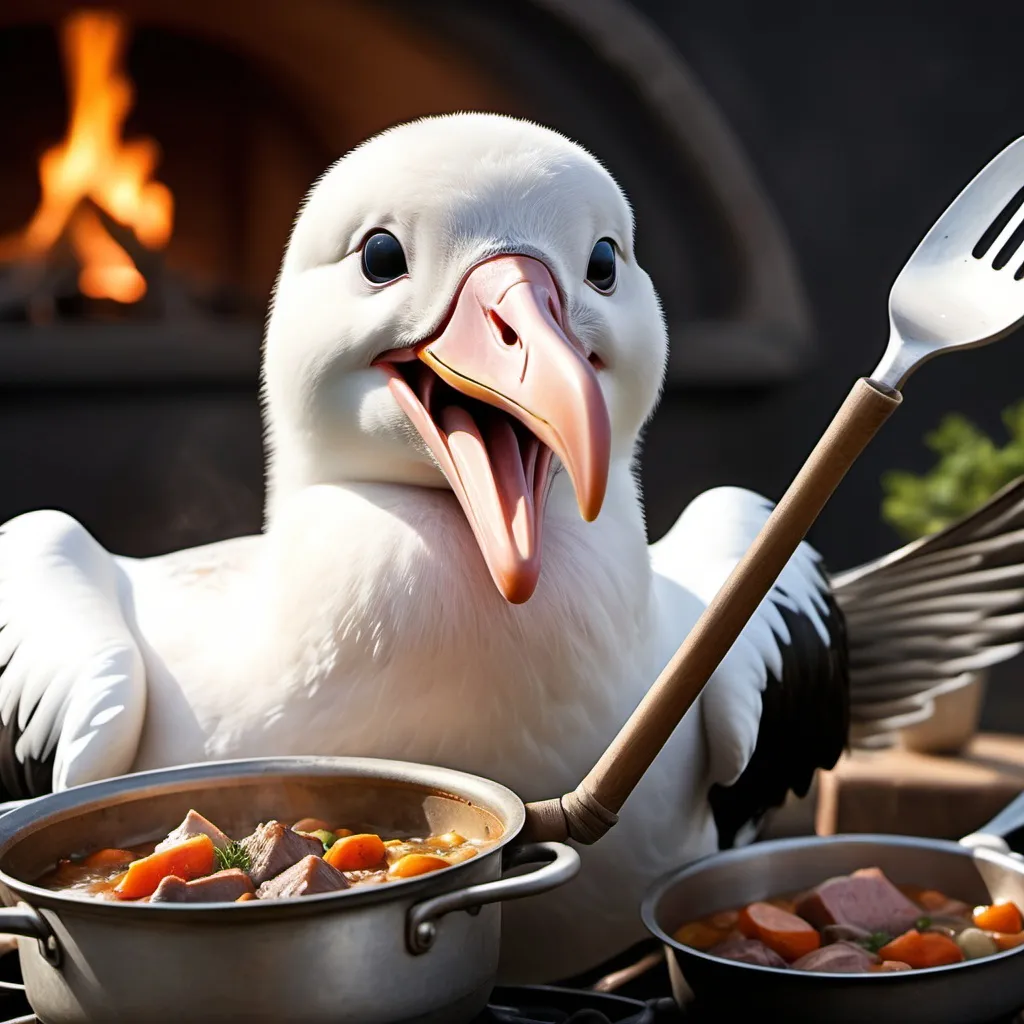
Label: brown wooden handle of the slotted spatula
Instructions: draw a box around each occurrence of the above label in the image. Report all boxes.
[526,378,902,843]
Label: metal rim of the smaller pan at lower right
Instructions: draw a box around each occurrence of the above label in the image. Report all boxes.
[640,833,1024,985]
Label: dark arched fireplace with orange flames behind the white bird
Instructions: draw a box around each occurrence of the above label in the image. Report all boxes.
[0,0,813,555]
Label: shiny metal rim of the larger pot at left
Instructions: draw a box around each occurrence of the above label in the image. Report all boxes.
[0,757,525,922]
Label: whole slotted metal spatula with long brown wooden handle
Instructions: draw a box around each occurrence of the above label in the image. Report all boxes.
[526,132,1024,843]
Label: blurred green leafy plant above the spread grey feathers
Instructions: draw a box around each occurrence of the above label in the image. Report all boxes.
[882,401,1024,540]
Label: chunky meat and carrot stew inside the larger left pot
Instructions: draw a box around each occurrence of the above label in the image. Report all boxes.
[39,810,494,903]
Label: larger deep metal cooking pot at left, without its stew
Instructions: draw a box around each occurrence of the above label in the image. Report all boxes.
[0,758,580,1024]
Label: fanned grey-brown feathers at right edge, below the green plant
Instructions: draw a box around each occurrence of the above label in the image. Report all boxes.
[833,477,1024,748]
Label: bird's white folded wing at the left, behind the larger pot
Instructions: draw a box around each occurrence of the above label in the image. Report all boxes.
[0,512,145,799]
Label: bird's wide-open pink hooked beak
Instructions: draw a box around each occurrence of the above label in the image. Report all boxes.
[377,256,611,604]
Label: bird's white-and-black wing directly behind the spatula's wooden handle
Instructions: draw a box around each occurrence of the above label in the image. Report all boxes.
[651,487,849,847]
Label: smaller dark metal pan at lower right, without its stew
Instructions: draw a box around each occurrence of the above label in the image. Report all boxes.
[641,795,1024,1024]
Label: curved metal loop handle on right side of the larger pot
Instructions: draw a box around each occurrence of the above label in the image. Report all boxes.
[409,843,580,956]
